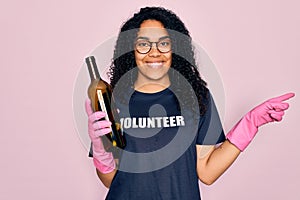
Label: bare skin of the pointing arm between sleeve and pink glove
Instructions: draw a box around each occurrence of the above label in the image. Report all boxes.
[197,140,241,185]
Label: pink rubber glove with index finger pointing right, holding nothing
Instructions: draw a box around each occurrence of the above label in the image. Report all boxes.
[226,93,295,151]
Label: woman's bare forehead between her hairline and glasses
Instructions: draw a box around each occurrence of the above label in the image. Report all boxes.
[137,20,169,41]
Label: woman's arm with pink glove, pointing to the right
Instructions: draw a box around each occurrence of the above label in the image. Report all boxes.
[197,93,295,184]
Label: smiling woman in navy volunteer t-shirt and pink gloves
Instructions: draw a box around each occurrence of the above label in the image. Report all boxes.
[86,7,294,200]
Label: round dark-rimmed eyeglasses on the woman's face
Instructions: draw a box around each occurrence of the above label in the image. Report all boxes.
[135,37,171,54]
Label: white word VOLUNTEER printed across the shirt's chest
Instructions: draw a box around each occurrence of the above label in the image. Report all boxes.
[120,116,185,129]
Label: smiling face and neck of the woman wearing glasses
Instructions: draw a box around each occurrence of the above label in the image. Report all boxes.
[135,20,172,92]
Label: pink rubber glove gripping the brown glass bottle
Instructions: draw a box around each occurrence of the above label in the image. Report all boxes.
[85,99,116,174]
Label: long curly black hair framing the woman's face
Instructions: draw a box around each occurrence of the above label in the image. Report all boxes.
[109,7,209,115]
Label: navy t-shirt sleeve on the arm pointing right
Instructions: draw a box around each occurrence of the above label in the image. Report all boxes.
[196,93,225,145]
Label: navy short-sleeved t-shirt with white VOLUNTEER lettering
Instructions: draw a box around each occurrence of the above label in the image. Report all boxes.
[106,88,225,200]
